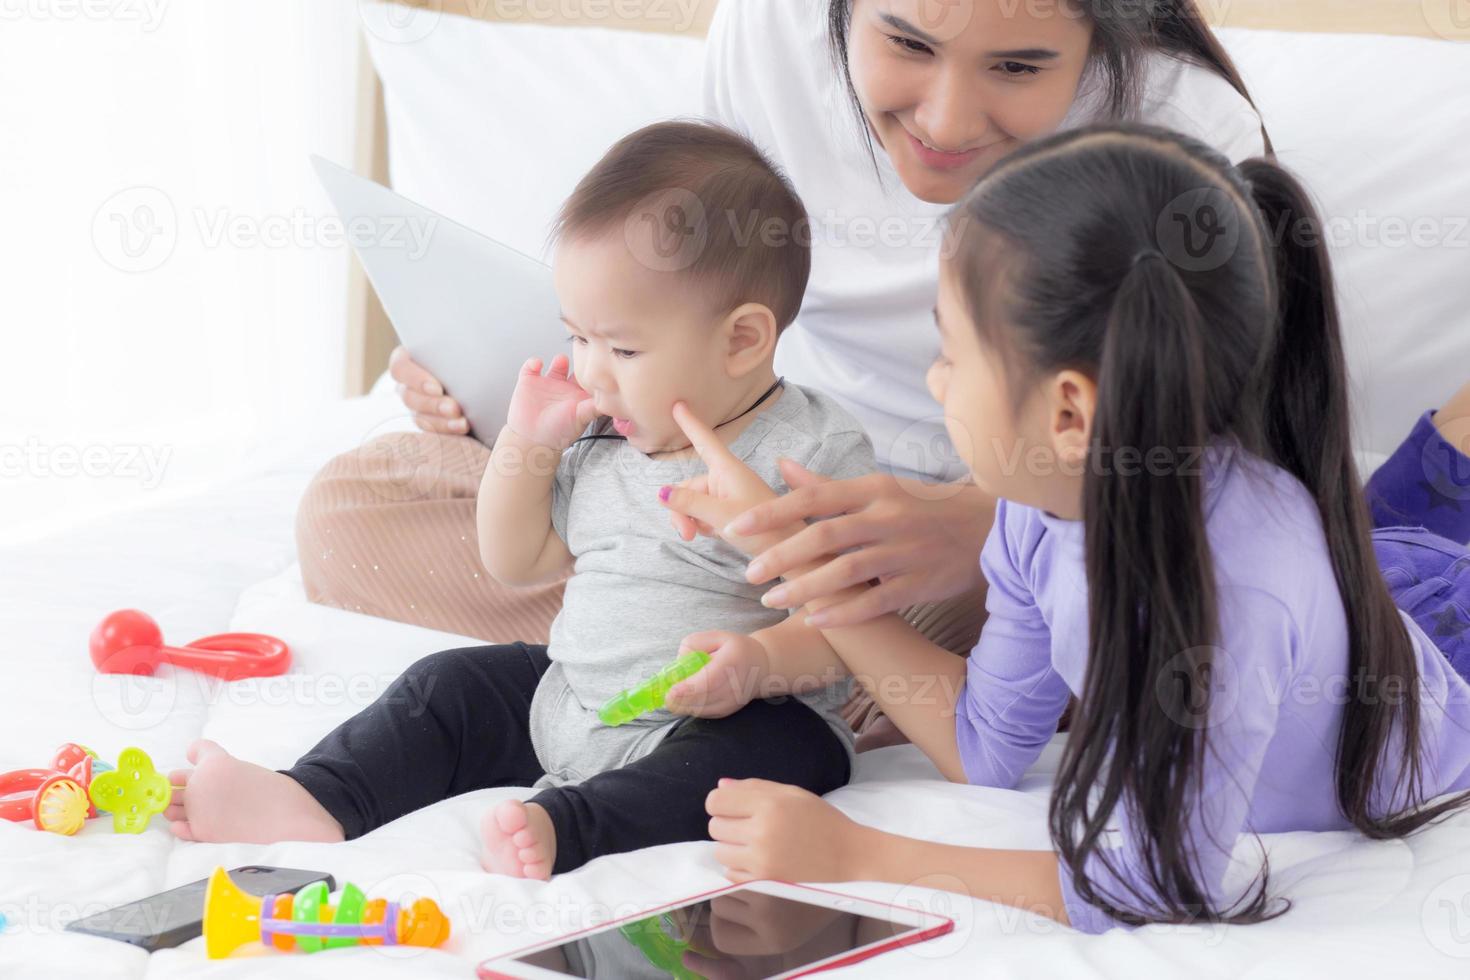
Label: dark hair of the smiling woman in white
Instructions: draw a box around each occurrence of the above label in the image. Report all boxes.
[826,0,1272,170]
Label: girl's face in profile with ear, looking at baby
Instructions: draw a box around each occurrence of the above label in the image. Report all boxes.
[928,255,1097,520]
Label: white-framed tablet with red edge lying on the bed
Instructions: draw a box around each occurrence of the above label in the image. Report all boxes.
[478,882,954,980]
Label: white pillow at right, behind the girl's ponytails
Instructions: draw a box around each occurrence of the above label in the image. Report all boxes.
[1220,29,1470,455]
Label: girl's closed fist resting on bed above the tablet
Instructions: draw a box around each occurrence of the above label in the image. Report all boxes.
[704,779,867,882]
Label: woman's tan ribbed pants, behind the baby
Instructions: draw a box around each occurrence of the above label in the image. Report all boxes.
[295,432,985,732]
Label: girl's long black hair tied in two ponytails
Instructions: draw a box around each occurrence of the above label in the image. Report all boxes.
[945,125,1467,923]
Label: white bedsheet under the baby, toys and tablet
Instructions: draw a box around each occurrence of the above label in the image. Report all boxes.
[0,392,1470,980]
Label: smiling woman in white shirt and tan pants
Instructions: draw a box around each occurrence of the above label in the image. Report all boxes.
[297,0,1269,705]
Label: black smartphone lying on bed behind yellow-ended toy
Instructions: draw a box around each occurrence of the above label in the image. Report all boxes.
[66,864,337,952]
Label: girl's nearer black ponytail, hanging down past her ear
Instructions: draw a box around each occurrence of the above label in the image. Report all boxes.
[1050,247,1264,923]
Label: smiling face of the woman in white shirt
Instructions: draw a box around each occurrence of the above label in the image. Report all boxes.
[848,0,1092,204]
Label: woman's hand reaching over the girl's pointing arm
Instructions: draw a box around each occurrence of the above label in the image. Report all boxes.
[726,460,995,627]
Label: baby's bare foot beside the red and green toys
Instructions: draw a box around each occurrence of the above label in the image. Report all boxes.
[163,739,343,843]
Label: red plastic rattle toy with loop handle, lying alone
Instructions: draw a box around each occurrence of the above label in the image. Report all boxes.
[88,610,291,680]
